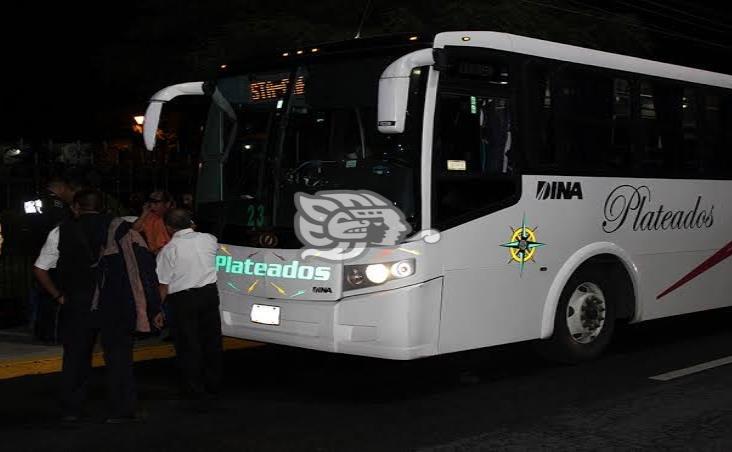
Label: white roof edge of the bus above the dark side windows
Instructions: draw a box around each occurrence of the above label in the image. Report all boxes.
[434,31,732,89]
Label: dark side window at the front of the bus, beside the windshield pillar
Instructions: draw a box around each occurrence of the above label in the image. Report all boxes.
[433,53,518,229]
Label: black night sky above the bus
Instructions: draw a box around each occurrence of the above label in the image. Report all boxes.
[0,0,732,140]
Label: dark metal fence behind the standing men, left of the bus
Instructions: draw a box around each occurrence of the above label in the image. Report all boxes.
[0,139,198,310]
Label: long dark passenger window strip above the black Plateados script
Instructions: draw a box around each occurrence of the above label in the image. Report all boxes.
[520,59,732,178]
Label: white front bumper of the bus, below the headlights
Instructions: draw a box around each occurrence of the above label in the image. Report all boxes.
[221,278,442,360]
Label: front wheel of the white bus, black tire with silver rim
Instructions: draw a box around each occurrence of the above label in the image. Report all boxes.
[539,266,616,364]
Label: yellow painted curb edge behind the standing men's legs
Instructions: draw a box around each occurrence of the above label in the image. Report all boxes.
[0,337,264,380]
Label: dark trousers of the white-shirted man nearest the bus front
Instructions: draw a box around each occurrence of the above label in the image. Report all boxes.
[166,284,222,394]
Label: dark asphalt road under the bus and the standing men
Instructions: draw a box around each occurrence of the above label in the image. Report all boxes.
[0,311,732,451]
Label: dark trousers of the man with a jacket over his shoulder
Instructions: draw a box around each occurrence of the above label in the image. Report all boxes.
[61,308,137,417]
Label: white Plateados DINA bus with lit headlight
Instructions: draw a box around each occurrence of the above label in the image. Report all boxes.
[145,31,732,361]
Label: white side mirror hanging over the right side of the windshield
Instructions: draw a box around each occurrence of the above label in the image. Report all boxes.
[377,49,435,133]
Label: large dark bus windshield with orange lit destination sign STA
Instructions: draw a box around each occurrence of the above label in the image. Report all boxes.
[197,56,428,248]
